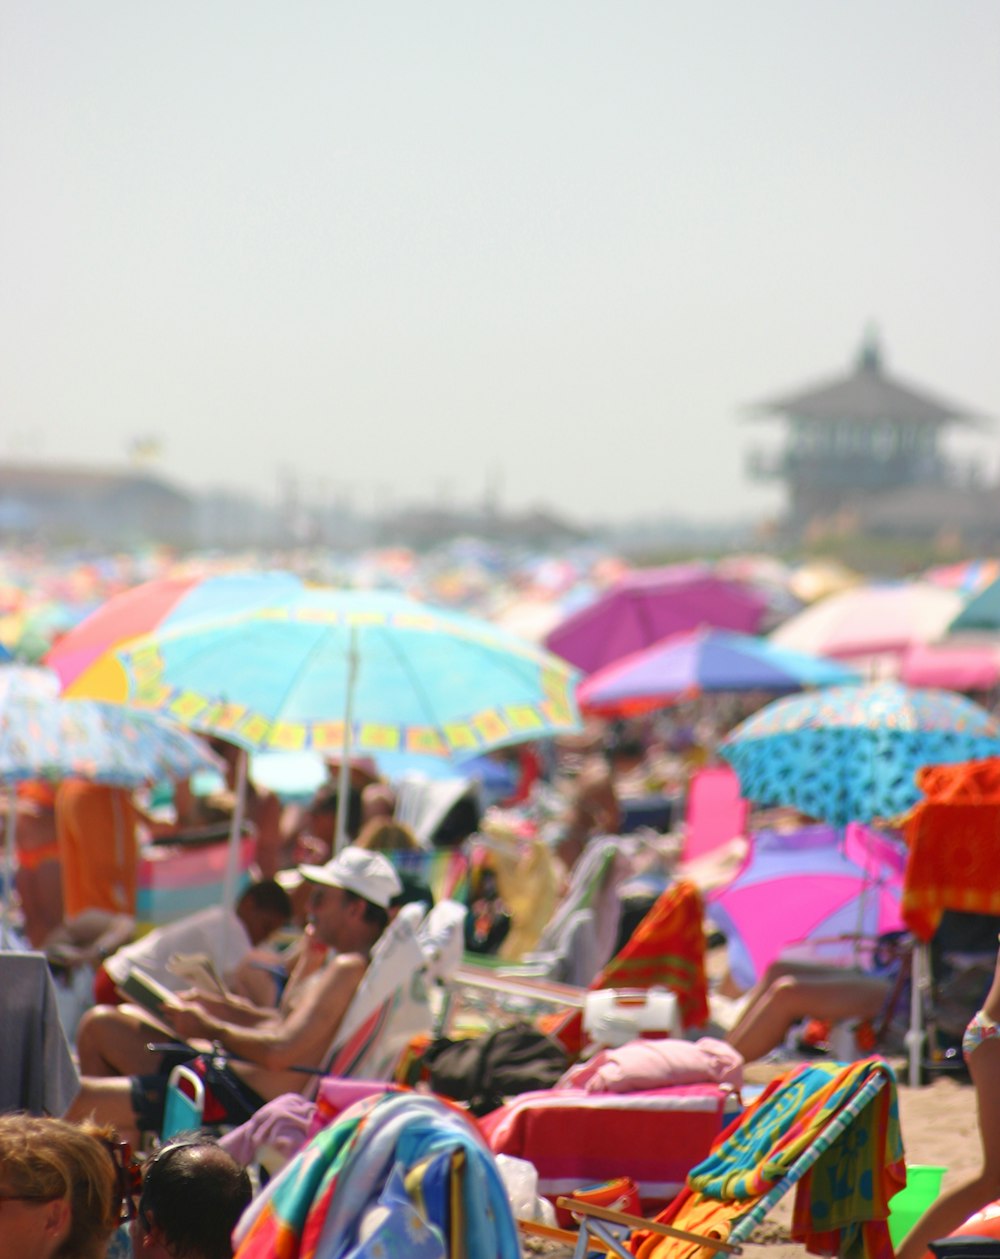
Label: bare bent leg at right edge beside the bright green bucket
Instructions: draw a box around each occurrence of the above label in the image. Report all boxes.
[895,1037,1000,1259]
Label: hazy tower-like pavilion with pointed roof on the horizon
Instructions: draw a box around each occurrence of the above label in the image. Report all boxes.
[747,335,985,533]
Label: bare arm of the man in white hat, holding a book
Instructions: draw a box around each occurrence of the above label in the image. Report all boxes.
[164,953,366,1070]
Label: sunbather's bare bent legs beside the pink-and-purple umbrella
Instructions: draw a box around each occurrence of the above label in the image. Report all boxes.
[725,973,889,1063]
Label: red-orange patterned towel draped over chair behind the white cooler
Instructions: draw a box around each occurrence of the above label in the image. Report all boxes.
[543,881,708,1056]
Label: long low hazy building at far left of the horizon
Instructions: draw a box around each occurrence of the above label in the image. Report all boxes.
[0,462,195,548]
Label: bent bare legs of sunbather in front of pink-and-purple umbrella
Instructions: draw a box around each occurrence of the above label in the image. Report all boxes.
[725,961,892,1063]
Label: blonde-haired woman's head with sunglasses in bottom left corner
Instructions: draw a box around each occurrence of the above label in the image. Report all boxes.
[0,1114,123,1259]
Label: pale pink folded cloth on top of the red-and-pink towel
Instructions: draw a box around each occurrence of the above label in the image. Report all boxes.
[555,1036,743,1093]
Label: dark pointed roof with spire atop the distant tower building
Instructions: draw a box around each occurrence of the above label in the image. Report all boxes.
[751,335,992,428]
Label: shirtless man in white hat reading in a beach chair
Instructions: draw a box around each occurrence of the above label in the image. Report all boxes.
[67,847,402,1136]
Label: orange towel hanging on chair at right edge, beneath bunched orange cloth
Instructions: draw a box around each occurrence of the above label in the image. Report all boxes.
[902,795,1000,940]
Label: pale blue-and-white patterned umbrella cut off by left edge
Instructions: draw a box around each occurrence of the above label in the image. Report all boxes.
[0,667,219,943]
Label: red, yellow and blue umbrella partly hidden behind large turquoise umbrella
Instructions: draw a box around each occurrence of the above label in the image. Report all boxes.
[44,572,302,700]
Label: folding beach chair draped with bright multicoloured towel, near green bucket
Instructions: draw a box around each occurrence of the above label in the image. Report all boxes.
[560,1058,906,1259]
